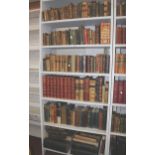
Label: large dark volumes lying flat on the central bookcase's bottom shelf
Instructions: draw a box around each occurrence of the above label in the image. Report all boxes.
[44,126,105,155]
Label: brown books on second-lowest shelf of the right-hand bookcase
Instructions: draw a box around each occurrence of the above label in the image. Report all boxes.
[111,111,126,133]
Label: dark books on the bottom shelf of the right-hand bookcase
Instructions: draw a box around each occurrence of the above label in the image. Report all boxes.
[110,136,126,155]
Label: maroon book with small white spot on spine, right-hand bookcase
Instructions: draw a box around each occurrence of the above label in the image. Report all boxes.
[118,80,124,103]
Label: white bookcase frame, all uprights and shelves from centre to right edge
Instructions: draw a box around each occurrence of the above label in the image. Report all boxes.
[39,0,126,155]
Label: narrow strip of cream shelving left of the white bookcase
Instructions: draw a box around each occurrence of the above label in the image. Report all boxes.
[29,0,41,137]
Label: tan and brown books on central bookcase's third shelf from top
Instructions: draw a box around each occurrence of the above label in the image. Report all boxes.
[43,54,110,73]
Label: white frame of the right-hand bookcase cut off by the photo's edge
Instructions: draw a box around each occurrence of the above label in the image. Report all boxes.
[109,0,126,155]
